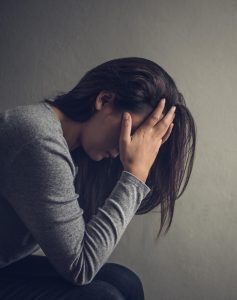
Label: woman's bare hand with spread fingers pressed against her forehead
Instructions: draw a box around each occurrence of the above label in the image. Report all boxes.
[119,101,175,182]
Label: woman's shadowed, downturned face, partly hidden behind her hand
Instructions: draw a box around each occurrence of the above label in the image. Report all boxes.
[81,93,152,161]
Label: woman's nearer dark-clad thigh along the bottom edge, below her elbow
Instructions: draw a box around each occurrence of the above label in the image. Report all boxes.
[0,278,125,300]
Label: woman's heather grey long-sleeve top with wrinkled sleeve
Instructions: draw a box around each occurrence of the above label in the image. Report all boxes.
[0,101,150,285]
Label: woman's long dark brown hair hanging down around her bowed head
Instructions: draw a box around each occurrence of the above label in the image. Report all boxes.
[44,57,196,238]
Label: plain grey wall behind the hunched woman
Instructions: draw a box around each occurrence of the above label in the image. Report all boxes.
[0,0,237,300]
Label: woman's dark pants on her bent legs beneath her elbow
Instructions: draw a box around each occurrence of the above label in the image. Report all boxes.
[0,255,144,300]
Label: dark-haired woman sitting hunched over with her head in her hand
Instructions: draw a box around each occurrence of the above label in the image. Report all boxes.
[0,57,196,300]
